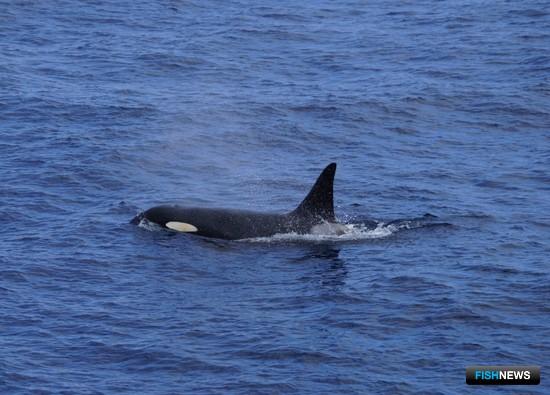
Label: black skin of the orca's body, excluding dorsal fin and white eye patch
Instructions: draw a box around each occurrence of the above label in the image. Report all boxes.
[132,205,323,240]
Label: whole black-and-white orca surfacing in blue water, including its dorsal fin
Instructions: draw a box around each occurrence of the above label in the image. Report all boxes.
[131,163,336,240]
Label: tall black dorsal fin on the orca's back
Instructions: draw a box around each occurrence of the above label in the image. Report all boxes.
[291,163,336,222]
